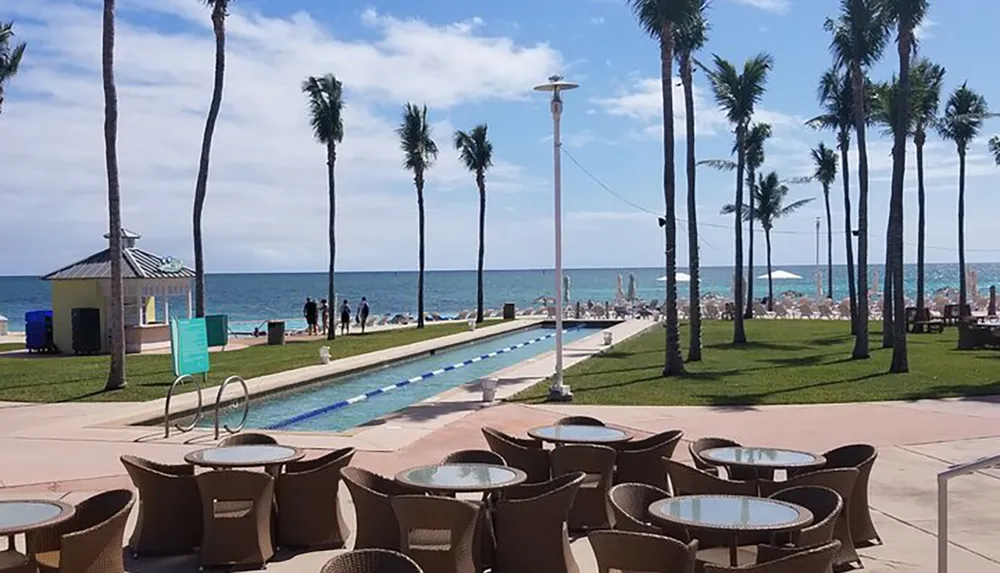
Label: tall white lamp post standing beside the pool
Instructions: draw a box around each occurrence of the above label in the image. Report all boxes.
[535,75,579,401]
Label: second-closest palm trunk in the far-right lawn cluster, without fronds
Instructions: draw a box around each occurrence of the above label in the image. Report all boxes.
[851,59,871,359]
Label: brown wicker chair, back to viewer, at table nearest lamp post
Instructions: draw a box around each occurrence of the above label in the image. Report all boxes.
[552,445,617,531]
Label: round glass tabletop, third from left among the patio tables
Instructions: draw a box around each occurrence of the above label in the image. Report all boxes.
[396,464,527,491]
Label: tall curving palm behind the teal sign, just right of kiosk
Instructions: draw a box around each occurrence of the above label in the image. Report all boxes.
[192,0,230,316]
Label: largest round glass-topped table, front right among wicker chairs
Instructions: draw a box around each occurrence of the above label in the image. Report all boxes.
[649,495,813,566]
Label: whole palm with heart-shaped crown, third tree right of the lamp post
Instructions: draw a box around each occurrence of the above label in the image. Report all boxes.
[704,53,774,344]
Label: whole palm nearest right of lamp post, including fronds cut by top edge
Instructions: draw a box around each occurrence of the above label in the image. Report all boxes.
[629,0,694,376]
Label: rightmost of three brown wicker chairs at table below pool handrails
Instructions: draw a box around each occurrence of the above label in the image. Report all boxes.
[276,448,354,548]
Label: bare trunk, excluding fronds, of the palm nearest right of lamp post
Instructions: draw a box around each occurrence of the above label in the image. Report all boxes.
[660,31,684,376]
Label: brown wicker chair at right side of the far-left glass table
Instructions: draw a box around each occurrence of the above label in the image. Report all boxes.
[27,489,136,573]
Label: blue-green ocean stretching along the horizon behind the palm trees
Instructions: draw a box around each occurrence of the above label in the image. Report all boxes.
[0,263,1000,331]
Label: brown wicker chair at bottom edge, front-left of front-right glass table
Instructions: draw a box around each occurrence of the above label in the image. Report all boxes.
[587,531,698,573]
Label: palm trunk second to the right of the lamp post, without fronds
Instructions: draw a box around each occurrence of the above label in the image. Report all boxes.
[681,52,701,362]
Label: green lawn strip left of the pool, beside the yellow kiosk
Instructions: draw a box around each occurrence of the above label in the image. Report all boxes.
[0,323,480,402]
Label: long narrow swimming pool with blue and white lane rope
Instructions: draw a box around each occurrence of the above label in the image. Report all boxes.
[201,326,601,432]
